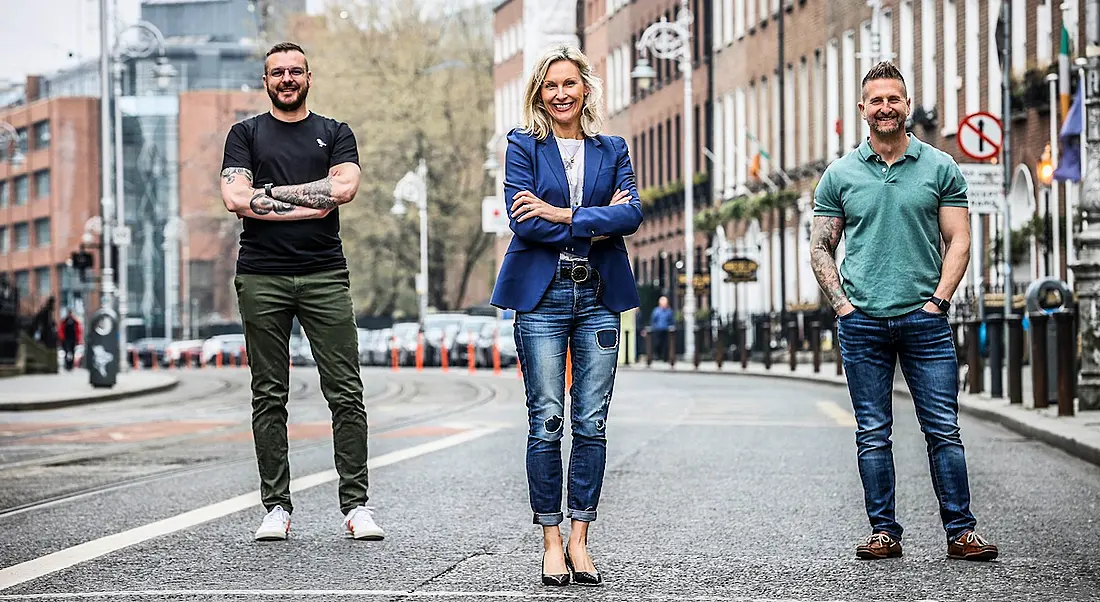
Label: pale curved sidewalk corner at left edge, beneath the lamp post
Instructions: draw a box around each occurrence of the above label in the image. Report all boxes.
[0,370,179,412]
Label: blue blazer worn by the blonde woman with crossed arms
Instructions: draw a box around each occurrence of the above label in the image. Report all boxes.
[490,129,641,311]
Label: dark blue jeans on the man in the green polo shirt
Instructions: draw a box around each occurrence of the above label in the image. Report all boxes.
[838,309,976,539]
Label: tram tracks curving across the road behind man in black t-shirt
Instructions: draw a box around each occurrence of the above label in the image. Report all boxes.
[0,374,501,521]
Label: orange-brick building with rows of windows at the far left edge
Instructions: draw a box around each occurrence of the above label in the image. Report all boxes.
[0,83,100,321]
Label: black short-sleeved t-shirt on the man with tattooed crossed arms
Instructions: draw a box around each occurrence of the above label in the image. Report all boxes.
[221,112,359,275]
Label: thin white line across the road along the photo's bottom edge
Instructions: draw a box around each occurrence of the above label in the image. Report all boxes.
[0,590,902,602]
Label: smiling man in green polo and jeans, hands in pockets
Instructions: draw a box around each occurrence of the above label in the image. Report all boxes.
[810,62,998,560]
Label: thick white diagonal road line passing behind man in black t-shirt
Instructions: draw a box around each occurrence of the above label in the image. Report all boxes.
[0,428,497,600]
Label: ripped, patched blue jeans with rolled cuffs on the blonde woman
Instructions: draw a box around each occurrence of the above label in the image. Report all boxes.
[515,265,619,526]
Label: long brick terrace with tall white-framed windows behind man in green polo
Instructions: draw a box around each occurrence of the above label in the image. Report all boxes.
[497,0,1084,330]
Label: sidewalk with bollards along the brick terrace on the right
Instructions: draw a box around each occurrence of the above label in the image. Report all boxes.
[619,361,1100,466]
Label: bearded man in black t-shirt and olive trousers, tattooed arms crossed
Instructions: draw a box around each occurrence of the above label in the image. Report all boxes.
[221,43,384,540]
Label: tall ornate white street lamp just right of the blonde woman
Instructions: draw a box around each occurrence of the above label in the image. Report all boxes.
[630,0,695,358]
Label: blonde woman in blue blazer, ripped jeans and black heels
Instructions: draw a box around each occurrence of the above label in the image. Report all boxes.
[492,45,642,585]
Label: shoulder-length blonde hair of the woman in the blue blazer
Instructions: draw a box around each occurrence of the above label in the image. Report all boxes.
[523,44,604,140]
